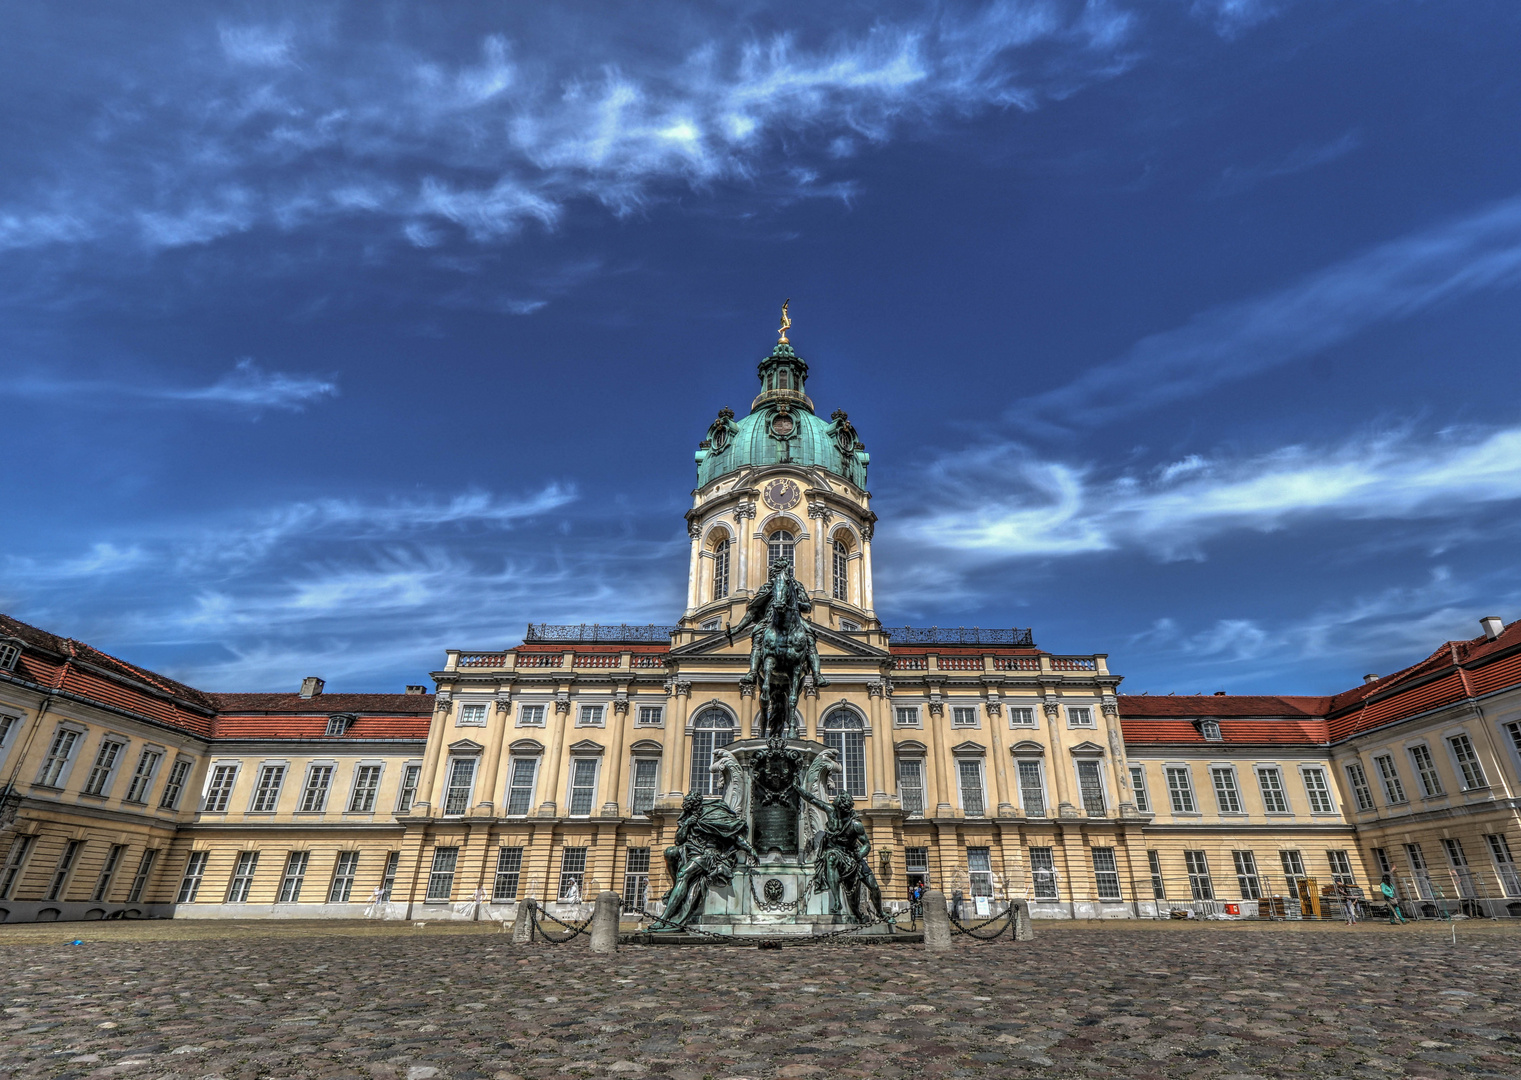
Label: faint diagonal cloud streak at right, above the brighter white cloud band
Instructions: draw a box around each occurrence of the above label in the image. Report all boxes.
[1008,198,1521,426]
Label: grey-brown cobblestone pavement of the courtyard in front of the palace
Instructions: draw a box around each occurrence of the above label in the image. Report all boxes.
[0,922,1521,1080]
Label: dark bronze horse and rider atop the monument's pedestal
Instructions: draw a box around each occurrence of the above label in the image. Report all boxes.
[724,558,829,739]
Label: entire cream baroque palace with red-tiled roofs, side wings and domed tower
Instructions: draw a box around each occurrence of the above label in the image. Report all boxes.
[0,335,1521,922]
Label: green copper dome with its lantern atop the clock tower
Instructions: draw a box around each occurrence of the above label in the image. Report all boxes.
[697,341,872,490]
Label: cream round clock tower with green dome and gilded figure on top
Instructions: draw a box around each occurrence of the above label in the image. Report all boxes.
[681,315,879,631]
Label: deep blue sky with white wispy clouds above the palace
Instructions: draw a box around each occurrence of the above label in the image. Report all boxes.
[0,0,1521,692]
